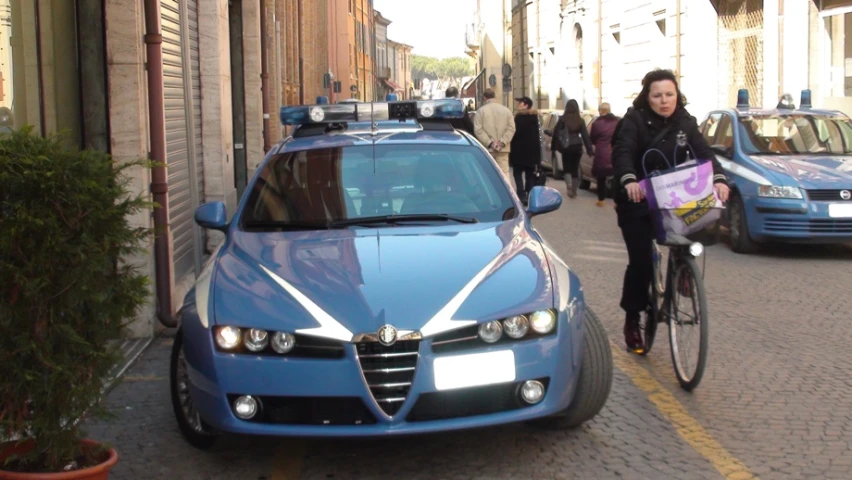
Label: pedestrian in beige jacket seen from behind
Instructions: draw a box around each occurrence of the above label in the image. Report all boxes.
[473,88,515,178]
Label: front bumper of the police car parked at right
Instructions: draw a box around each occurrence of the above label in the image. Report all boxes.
[743,197,852,243]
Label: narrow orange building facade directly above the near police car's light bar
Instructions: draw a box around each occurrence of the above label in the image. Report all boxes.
[328,0,375,102]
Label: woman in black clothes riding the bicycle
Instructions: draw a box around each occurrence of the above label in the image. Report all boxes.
[612,70,730,352]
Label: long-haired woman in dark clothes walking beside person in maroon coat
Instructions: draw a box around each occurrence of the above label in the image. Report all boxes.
[551,99,594,198]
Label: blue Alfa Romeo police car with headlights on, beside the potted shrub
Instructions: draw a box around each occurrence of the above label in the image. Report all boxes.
[170,95,612,448]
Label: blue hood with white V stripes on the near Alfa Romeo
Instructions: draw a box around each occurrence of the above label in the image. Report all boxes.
[213,219,553,341]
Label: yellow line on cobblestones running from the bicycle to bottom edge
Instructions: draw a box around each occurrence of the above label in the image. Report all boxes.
[612,343,758,480]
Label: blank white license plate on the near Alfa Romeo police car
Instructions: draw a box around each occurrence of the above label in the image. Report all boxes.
[432,350,515,390]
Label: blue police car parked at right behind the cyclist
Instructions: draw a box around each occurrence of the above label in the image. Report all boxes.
[701,90,852,253]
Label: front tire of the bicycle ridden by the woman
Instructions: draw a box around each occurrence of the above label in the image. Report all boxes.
[669,258,710,392]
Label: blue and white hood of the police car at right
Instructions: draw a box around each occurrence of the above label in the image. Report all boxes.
[751,155,852,189]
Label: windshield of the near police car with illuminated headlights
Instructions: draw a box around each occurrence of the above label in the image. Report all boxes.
[241,145,516,229]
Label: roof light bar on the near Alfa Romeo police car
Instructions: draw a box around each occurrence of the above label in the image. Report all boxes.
[279,98,464,125]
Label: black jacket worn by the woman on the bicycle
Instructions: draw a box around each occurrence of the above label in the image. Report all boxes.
[612,107,727,216]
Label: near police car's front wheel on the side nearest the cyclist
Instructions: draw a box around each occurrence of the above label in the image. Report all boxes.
[529,307,613,429]
